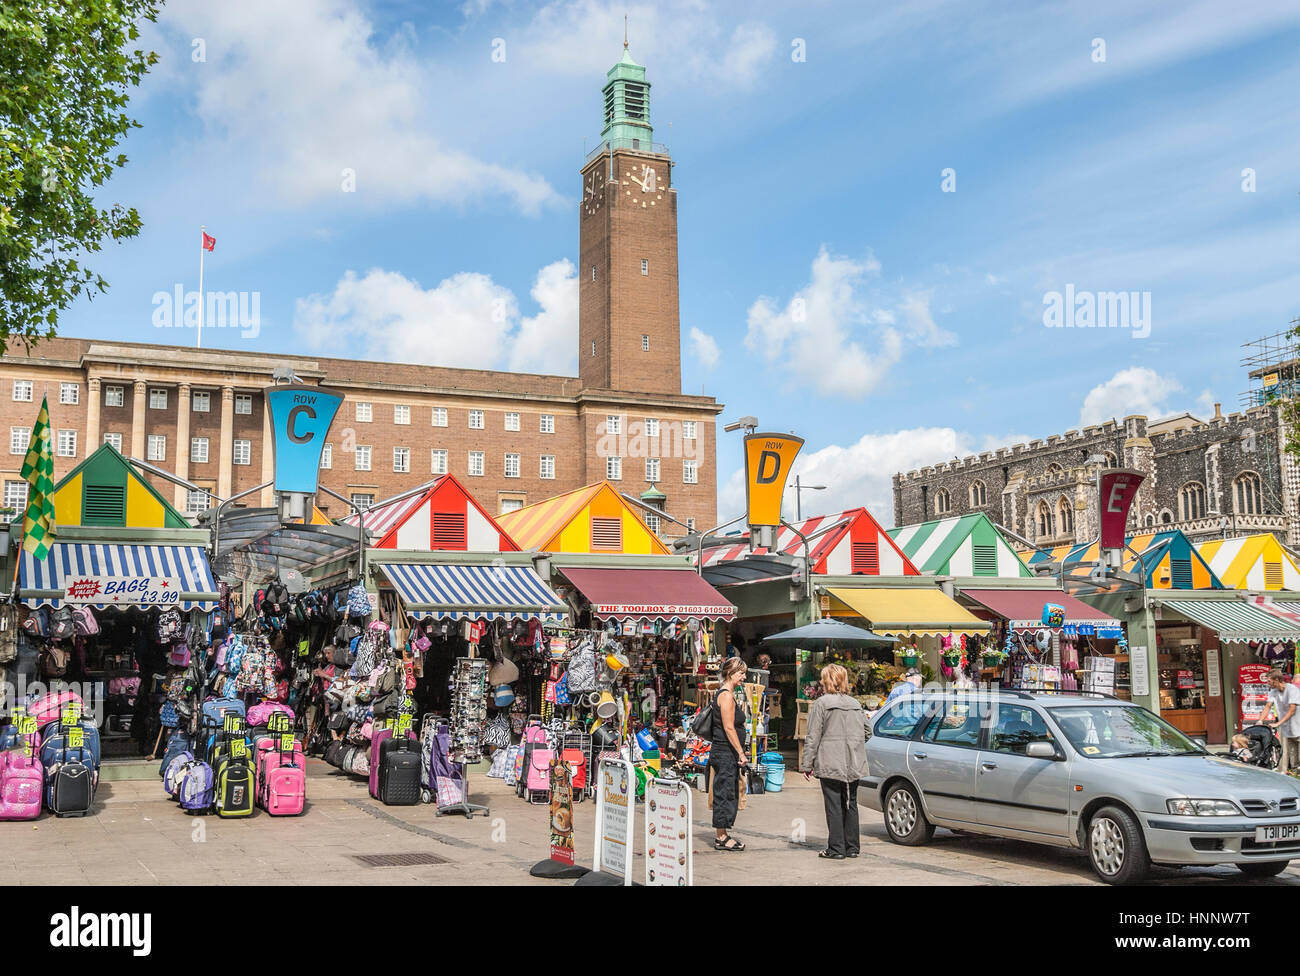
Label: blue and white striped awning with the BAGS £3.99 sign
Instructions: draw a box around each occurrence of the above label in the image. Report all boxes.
[18,542,218,610]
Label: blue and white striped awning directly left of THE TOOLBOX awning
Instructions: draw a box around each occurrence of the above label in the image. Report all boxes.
[380,563,566,620]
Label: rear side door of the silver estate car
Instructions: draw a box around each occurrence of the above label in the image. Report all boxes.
[907,700,980,824]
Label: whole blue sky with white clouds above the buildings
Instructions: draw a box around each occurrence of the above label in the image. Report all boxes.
[55,0,1300,522]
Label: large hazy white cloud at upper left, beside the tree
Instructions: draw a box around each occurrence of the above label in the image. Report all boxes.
[163,0,559,214]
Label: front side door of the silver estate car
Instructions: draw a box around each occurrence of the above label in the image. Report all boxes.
[975,702,1070,838]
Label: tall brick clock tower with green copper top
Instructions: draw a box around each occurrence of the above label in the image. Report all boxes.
[579,40,681,395]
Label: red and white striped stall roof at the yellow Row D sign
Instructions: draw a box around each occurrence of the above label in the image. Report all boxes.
[703,508,920,576]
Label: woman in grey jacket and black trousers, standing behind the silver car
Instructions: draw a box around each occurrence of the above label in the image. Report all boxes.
[800,664,867,860]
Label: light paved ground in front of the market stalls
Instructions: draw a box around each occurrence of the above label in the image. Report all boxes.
[0,760,1300,886]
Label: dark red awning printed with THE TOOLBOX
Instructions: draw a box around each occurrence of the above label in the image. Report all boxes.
[562,569,736,620]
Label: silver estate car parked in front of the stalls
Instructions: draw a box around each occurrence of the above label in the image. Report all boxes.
[861,690,1300,884]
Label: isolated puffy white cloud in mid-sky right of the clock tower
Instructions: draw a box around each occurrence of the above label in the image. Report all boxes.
[745,246,957,399]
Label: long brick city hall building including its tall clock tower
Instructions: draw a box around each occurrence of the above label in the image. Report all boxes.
[0,48,722,537]
